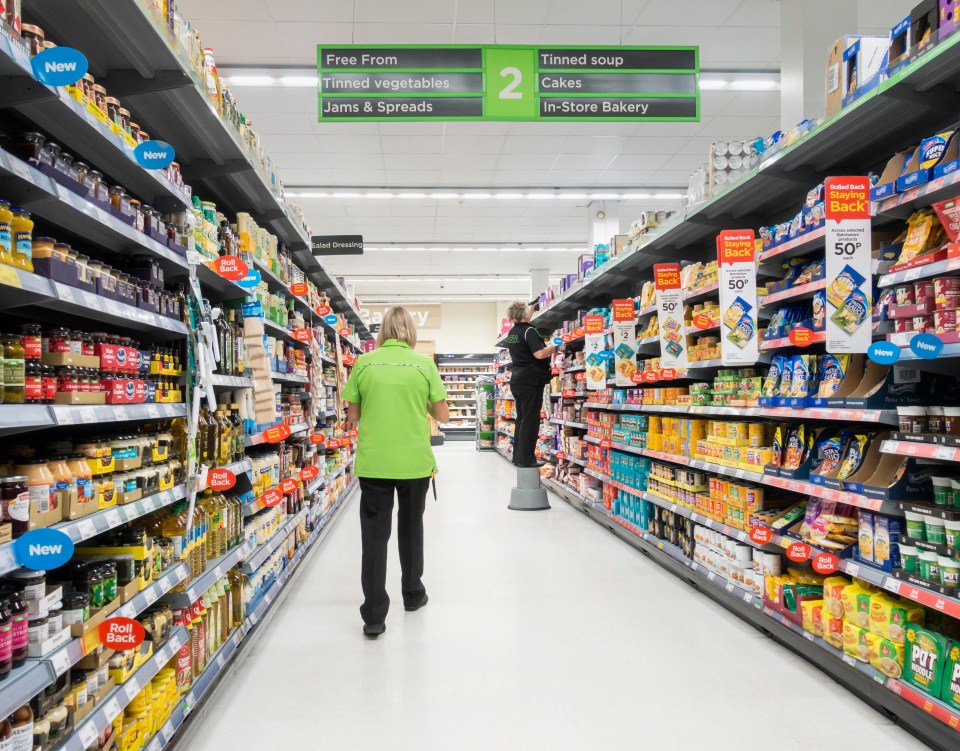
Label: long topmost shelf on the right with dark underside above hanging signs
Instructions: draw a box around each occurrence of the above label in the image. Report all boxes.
[532,35,960,329]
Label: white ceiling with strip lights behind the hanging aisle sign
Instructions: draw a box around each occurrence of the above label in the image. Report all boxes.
[178,0,912,298]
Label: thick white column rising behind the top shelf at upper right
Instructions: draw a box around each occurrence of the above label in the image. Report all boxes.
[780,0,858,131]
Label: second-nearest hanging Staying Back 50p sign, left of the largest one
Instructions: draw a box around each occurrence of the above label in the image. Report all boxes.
[717,229,760,367]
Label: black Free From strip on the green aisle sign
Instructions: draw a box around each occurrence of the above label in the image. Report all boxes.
[317,47,483,71]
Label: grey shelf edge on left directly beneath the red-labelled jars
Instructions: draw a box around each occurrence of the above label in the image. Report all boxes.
[0,404,187,434]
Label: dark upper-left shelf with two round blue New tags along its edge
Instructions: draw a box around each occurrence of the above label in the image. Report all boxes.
[0,35,190,211]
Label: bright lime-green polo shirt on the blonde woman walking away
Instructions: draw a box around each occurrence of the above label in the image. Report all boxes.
[343,339,447,480]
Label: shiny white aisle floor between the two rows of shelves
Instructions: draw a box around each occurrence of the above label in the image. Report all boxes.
[185,443,924,751]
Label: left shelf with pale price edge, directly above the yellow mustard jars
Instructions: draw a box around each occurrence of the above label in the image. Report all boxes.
[0,149,187,278]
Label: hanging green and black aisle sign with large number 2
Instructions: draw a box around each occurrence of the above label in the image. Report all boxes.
[317,45,700,122]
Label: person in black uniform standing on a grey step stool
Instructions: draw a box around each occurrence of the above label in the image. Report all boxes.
[507,300,557,467]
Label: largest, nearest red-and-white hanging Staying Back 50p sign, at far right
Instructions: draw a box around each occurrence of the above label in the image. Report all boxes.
[824,177,873,353]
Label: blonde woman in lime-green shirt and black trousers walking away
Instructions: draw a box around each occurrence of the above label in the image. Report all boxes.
[343,307,450,638]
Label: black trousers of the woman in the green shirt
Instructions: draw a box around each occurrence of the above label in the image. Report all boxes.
[360,477,430,624]
